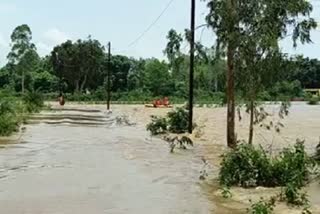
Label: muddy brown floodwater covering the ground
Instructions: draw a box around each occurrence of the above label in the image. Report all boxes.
[0,104,320,214]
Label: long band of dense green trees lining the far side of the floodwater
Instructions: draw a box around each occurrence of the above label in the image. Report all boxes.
[0,25,320,100]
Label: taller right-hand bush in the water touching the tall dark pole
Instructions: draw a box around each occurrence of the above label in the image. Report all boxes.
[167,108,189,134]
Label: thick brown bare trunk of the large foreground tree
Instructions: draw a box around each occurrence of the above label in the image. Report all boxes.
[227,43,237,148]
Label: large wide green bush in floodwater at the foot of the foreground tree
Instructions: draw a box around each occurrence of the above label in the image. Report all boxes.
[219,142,315,187]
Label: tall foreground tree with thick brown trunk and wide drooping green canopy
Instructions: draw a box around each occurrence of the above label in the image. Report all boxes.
[207,0,317,147]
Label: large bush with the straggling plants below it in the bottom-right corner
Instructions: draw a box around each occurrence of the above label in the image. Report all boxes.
[219,140,319,214]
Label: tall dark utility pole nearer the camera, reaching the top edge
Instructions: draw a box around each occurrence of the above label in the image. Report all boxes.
[188,0,196,134]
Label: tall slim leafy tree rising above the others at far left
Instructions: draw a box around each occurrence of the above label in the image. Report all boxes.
[7,24,39,93]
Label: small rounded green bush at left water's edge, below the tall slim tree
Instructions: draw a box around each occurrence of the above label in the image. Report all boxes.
[23,91,44,113]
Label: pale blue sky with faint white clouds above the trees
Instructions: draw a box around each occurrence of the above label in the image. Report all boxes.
[0,0,320,65]
